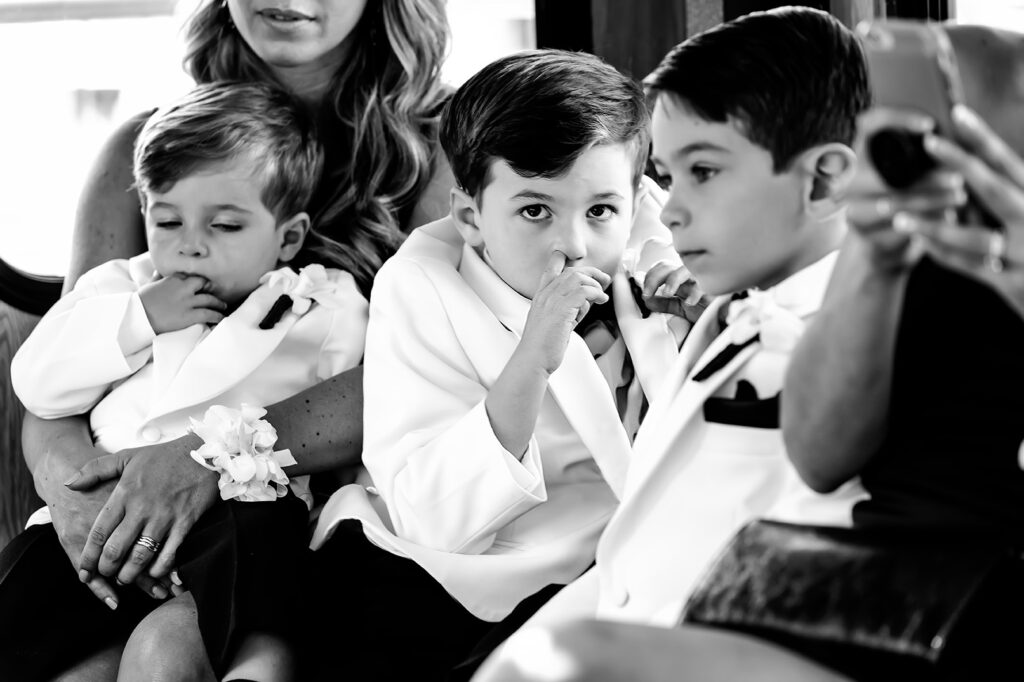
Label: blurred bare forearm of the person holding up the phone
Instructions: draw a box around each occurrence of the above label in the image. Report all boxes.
[782,240,908,492]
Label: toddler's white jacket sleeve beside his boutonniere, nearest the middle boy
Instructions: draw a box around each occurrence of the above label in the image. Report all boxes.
[316,270,369,381]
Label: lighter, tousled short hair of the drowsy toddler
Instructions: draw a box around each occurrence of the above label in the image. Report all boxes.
[134,81,324,220]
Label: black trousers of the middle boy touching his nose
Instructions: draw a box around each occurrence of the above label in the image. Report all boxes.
[302,521,562,682]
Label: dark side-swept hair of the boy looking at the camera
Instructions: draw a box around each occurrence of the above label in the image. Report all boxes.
[440,50,650,197]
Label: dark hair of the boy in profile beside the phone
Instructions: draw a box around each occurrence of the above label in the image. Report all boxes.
[644,7,870,172]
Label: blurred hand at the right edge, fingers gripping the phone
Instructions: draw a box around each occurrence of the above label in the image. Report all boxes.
[900,106,1024,316]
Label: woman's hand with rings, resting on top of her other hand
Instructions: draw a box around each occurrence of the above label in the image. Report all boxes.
[69,434,218,584]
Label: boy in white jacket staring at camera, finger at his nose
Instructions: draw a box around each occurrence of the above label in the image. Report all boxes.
[313,50,679,680]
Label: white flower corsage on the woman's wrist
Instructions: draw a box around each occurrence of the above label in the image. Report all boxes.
[188,403,295,502]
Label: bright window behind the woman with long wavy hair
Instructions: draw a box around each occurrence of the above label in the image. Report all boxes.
[0,0,535,274]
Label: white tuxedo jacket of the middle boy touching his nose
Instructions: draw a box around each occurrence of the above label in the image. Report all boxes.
[312,195,677,621]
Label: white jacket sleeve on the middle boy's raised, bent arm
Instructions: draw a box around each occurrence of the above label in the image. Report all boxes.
[364,258,547,554]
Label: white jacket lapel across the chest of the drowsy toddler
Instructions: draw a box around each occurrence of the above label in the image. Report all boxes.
[147,286,298,420]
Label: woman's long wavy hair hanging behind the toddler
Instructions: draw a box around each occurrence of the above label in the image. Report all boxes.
[184,0,449,293]
